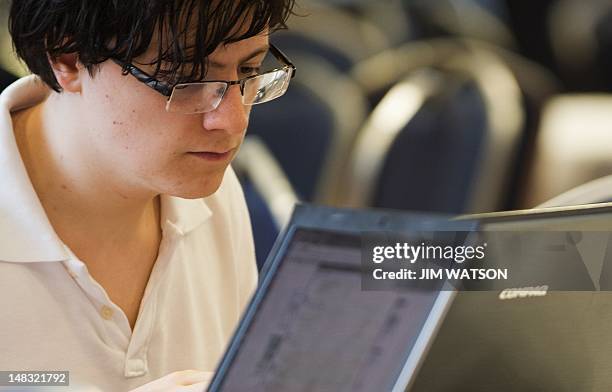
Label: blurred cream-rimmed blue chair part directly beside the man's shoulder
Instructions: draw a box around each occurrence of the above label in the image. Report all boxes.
[233,136,298,271]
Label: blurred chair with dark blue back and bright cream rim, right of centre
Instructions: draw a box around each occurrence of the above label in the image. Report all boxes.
[344,40,524,213]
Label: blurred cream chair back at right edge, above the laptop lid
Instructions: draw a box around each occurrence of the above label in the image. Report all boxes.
[522,94,612,207]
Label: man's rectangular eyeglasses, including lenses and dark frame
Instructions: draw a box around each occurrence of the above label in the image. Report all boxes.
[113,45,295,114]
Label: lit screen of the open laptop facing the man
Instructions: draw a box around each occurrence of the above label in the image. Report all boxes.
[219,228,448,391]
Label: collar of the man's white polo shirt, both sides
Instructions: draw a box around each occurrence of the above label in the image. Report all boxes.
[0,75,212,262]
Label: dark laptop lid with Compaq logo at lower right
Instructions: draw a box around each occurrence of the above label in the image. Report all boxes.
[410,203,612,392]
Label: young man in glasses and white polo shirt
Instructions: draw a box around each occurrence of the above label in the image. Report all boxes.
[0,0,294,391]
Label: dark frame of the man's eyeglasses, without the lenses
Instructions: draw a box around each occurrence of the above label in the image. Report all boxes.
[112,44,296,102]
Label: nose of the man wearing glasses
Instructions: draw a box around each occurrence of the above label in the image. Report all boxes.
[202,85,250,134]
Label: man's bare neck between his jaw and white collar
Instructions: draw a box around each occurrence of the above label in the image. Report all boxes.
[13,93,160,260]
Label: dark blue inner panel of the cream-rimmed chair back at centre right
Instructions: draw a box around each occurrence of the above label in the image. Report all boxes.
[373,77,487,213]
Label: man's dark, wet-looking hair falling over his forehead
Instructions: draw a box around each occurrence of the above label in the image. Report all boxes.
[9,0,295,92]
